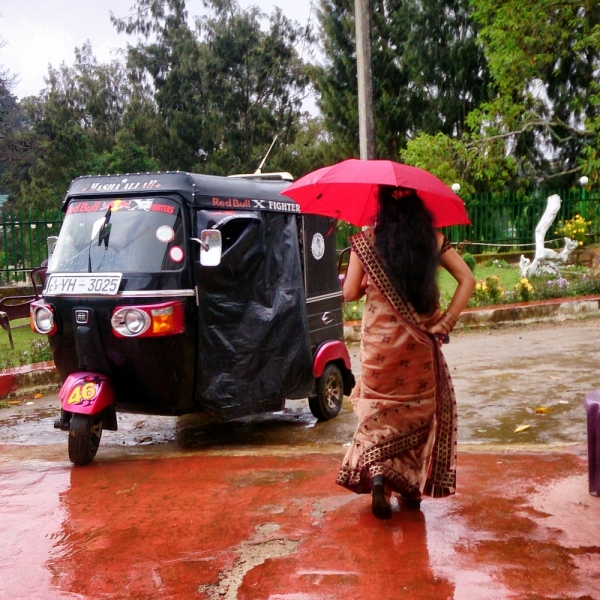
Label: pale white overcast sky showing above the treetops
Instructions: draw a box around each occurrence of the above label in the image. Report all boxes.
[0,0,316,98]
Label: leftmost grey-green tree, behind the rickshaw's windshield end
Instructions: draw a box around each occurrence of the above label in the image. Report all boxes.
[3,44,157,207]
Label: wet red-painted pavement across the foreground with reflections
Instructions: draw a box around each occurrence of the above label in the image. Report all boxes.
[0,447,600,600]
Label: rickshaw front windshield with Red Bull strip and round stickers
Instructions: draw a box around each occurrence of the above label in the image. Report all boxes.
[48,198,184,273]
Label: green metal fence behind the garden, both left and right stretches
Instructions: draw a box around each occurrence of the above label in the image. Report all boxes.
[0,189,600,285]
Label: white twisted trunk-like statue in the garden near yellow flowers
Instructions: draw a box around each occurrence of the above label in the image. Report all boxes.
[519,194,578,277]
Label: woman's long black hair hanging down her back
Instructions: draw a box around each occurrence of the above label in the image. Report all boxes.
[375,186,440,314]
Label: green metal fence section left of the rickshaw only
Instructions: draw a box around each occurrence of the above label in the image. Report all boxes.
[0,209,64,285]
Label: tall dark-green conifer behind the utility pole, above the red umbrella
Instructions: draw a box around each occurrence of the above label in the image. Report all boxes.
[313,0,489,159]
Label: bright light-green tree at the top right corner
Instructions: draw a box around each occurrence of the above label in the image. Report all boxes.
[404,0,600,189]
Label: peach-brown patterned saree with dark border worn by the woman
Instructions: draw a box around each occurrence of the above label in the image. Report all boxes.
[337,232,457,498]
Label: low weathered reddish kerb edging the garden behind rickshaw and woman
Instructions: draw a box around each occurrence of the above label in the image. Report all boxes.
[0,296,600,399]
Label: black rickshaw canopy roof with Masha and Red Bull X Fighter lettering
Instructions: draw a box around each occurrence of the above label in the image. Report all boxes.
[63,171,300,213]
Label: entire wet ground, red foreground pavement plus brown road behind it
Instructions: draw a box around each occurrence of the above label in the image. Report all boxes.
[0,319,600,600]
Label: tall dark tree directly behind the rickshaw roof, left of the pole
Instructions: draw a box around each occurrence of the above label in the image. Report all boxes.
[112,0,311,174]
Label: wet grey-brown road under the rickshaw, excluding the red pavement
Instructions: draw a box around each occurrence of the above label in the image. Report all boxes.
[0,318,600,450]
